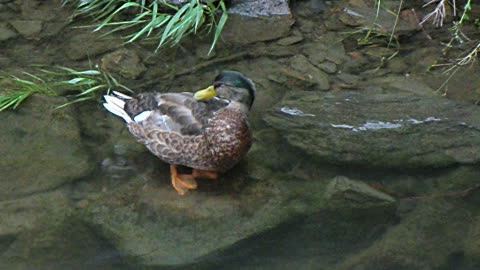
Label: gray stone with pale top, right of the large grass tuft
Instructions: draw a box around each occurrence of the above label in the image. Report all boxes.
[222,0,294,44]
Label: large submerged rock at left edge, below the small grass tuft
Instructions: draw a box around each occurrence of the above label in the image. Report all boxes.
[0,95,91,200]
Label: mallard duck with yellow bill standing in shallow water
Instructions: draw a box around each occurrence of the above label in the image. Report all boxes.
[103,71,256,195]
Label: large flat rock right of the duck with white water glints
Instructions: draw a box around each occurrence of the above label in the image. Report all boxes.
[264,89,480,168]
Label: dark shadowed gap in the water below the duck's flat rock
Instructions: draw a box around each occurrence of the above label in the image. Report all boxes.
[145,209,397,270]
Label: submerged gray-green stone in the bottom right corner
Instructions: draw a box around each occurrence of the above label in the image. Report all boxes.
[335,198,480,270]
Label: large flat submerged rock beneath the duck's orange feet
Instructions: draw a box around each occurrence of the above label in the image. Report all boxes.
[79,169,334,265]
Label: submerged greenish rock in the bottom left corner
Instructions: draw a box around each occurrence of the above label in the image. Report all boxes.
[0,189,120,270]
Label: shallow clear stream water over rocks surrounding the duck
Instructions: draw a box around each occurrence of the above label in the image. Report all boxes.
[0,1,480,270]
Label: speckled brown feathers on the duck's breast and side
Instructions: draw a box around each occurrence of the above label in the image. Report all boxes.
[126,94,251,172]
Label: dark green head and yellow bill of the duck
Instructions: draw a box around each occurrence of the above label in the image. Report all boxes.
[194,70,256,109]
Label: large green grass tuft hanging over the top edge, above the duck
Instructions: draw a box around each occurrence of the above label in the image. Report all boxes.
[63,0,228,54]
